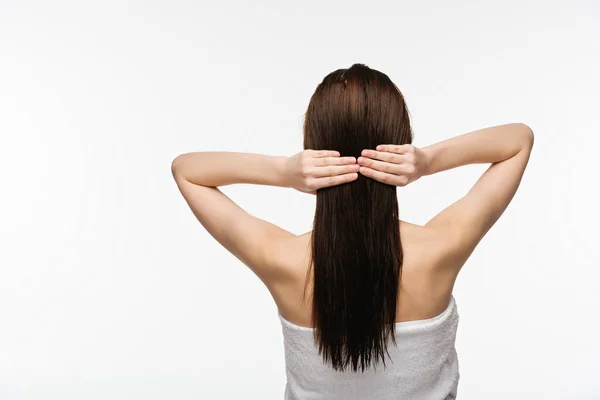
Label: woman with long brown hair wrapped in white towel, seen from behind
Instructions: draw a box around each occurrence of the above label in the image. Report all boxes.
[172,64,533,400]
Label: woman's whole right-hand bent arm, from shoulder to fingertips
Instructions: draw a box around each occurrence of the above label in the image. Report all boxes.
[358,124,533,277]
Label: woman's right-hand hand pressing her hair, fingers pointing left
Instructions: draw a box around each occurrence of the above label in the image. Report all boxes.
[358,144,429,186]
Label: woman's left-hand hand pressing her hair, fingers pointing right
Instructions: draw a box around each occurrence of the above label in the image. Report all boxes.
[283,150,359,194]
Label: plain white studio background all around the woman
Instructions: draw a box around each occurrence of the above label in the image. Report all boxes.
[0,0,600,400]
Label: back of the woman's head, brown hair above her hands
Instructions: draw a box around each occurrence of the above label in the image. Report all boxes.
[304,64,412,157]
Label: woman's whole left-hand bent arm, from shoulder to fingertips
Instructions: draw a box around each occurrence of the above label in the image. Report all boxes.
[171,150,358,285]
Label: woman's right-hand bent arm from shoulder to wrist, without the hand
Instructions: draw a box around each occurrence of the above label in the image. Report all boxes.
[423,124,534,278]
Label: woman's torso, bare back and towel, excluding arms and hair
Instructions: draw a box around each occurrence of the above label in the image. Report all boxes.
[271,221,460,400]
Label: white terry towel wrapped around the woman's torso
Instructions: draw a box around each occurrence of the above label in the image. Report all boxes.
[278,296,460,400]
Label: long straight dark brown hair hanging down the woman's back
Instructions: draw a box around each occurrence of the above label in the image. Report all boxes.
[304,64,413,371]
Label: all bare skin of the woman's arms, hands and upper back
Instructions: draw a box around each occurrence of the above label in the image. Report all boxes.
[172,123,533,327]
